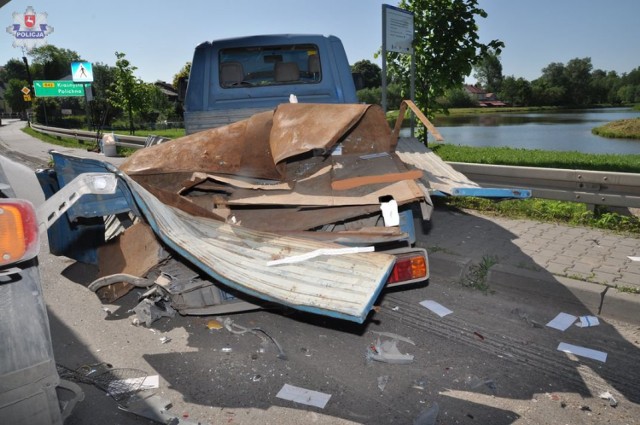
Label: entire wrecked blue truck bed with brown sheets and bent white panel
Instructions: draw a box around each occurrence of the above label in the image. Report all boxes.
[39,104,432,323]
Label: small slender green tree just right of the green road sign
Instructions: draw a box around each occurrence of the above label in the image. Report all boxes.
[109,52,144,134]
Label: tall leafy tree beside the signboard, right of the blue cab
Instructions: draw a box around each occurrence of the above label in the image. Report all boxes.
[388,0,504,116]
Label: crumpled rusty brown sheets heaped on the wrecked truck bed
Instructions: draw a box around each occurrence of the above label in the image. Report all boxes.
[120,103,428,237]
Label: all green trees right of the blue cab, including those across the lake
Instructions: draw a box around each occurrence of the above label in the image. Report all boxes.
[352,0,640,112]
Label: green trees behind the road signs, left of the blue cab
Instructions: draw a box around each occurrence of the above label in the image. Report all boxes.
[0,45,188,134]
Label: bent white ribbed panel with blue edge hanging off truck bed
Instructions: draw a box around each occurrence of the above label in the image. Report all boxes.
[117,175,395,323]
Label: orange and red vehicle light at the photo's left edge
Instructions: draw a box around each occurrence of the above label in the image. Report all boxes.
[0,199,40,267]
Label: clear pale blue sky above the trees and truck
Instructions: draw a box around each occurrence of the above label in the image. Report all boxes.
[0,0,640,82]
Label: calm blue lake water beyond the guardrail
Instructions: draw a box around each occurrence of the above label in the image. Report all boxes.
[422,108,640,154]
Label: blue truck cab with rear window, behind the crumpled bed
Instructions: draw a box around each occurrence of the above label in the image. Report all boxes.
[184,34,358,134]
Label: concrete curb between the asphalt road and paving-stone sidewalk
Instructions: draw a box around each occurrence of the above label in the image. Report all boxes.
[429,252,640,325]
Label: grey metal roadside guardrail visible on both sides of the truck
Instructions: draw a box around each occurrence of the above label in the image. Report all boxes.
[31,124,640,208]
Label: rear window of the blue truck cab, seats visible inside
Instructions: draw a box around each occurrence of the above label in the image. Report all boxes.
[218,44,322,88]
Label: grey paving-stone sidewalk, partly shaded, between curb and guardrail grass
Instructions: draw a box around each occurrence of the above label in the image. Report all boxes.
[423,208,640,291]
